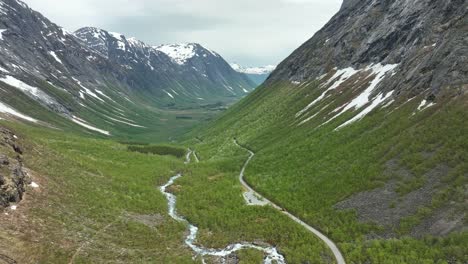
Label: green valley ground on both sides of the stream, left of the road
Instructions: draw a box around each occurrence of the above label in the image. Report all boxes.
[0,121,344,263]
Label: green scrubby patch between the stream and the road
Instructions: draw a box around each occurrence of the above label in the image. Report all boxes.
[174,142,332,263]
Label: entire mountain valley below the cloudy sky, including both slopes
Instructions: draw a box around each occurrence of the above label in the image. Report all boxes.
[0,0,468,264]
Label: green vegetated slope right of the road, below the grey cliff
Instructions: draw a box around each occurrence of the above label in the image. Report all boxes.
[187,83,468,263]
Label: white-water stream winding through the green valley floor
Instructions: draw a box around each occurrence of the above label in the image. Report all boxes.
[160,150,286,264]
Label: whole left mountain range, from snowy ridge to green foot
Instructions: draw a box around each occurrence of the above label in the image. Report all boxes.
[0,0,255,139]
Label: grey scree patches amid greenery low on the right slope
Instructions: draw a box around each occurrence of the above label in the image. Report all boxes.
[335,160,467,238]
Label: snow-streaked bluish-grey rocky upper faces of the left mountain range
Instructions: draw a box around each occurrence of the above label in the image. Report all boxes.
[0,0,255,125]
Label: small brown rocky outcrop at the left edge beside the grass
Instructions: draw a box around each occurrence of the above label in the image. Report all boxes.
[0,127,31,208]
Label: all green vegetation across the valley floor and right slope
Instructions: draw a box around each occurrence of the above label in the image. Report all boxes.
[0,72,468,263]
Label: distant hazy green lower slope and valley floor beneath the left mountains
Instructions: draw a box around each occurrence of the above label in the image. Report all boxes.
[0,78,225,142]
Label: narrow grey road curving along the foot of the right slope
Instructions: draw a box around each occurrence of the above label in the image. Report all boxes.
[234,139,346,264]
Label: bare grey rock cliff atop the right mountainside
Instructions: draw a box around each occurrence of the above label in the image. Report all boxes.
[269,0,468,100]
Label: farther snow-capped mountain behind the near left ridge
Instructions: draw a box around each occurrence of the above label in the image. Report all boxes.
[75,27,253,102]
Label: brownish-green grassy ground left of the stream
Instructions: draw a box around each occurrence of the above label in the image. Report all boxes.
[0,120,192,263]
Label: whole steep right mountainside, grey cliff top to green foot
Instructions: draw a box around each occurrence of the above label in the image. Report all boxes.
[193,0,468,263]
